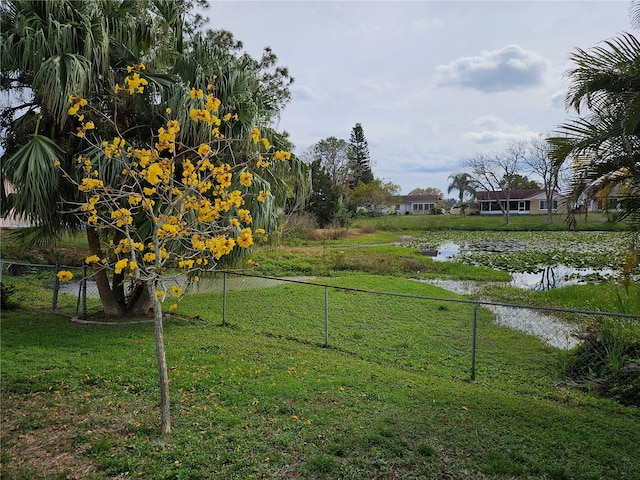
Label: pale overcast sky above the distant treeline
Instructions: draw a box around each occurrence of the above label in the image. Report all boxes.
[206,0,638,197]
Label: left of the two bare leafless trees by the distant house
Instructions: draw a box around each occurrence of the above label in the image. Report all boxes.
[465,142,526,225]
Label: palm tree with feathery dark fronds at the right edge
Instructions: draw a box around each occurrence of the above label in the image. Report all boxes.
[549,33,640,225]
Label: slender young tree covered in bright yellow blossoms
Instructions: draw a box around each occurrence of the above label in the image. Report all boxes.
[57,65,291,434]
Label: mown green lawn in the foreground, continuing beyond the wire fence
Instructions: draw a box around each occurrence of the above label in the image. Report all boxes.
[0,274,640,480]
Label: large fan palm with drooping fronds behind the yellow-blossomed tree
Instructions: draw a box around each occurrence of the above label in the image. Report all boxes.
[0,0,182,316]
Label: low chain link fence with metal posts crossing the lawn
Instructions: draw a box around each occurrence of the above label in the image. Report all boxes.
[1,261,640,405]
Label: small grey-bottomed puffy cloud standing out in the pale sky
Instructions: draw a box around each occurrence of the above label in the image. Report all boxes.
[436,45,550,93]
